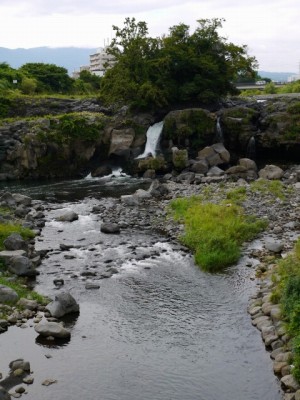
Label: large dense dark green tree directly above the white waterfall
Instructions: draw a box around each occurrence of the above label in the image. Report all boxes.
[101,18,257,109]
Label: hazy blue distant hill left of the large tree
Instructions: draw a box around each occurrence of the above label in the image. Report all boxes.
[0,47,96,75]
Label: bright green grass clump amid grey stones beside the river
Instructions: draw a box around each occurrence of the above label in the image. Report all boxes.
[171,197,267,272]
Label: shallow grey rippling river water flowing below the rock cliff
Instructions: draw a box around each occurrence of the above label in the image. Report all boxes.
[0,178,282,400]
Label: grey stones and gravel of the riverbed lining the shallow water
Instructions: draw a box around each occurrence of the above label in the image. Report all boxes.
[0,167,300,400]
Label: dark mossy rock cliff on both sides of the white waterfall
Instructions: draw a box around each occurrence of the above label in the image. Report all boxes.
[0,96,300,180]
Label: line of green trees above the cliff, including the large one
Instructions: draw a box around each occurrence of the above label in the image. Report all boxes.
[0,18,257,109]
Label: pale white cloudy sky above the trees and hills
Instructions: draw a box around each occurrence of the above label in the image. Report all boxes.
[0,0,300,73]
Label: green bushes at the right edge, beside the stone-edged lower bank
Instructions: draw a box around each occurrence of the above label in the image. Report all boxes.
[272,239,300,382]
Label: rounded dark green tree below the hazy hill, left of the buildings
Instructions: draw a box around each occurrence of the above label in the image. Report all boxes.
[19,63,73,93]
